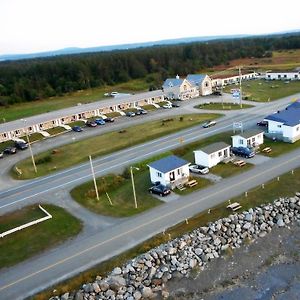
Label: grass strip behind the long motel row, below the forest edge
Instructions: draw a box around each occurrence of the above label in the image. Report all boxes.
[0,79,149,122]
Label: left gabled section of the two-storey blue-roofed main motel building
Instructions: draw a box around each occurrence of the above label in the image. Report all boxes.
[162,75,199,100]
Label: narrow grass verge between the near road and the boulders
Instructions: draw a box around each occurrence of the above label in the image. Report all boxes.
[33,169,300,300]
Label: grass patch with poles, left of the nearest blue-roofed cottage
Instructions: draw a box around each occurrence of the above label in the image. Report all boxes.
[71,170,161,217]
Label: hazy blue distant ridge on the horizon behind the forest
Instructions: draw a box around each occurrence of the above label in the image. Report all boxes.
[0,34,250,61]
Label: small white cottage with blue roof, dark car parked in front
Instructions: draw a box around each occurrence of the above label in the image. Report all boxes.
[148,155,190,188]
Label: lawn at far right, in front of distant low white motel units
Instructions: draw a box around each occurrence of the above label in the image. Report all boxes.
[224,80,300,102]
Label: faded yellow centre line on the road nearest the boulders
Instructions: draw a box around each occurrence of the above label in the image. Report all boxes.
[0,155,300,291]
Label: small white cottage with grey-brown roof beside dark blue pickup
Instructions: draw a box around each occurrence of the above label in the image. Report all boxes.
[231,130,264,148]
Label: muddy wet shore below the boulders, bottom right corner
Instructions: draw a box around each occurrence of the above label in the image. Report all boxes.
[166,225,300,300]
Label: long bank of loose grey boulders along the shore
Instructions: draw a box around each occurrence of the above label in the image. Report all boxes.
[51,193,300,300]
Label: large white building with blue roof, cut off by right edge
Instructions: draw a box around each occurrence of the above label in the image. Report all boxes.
[264,100,300,143]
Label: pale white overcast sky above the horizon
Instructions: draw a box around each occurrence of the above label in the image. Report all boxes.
[0,0,300,55]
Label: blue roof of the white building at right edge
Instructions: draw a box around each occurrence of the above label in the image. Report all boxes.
[265,100,300,126]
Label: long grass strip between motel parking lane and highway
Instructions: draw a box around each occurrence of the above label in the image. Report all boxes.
[12,114,221,179]
